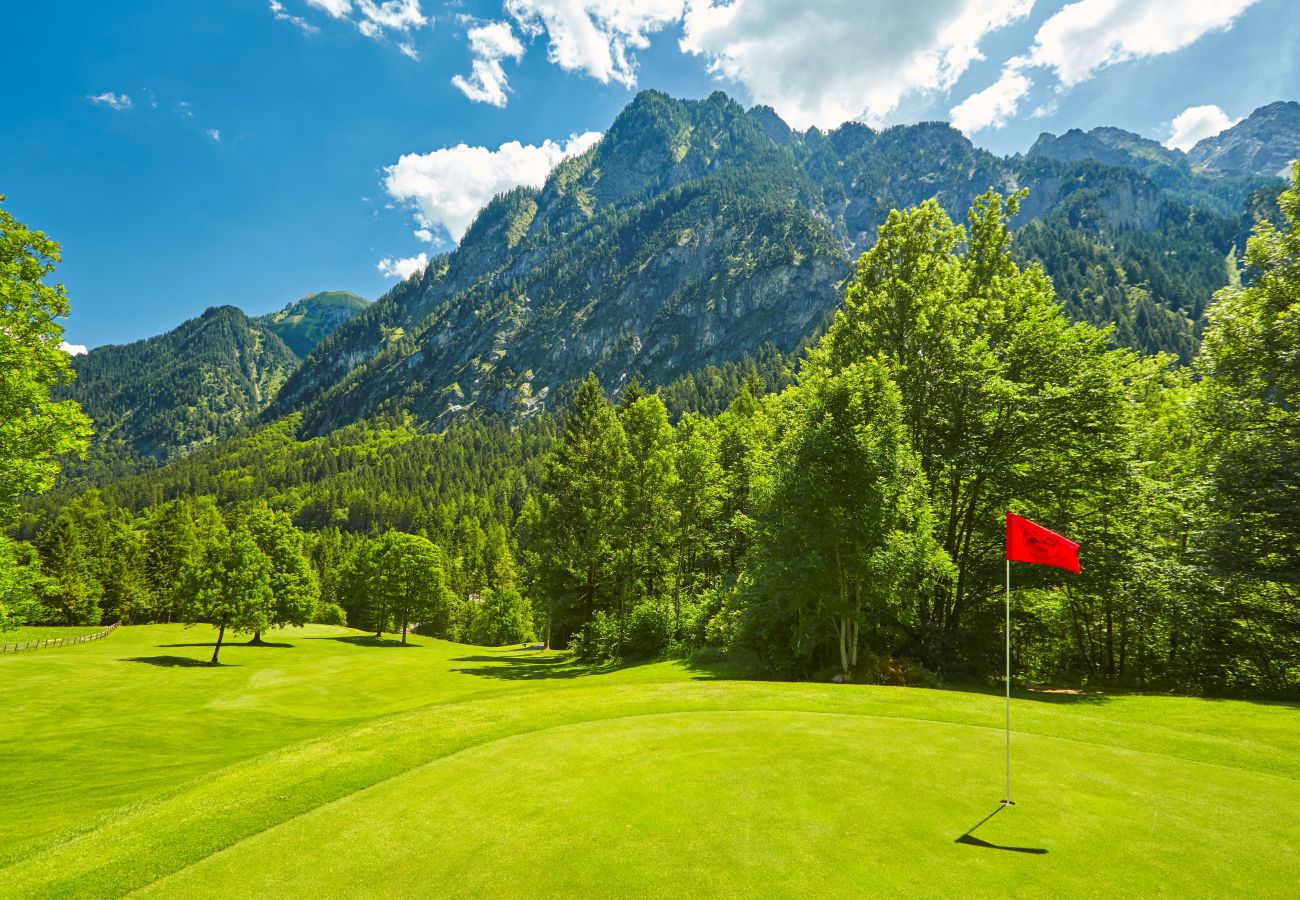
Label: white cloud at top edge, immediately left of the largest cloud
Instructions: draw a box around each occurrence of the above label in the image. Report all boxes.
[506,0,686,87]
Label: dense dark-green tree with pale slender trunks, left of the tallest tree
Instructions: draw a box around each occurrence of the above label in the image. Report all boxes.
[744,360,950,678]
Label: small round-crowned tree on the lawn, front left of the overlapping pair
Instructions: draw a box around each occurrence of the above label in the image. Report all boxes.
[185,528,273,666]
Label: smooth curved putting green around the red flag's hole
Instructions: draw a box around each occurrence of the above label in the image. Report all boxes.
[134,711,1300,897]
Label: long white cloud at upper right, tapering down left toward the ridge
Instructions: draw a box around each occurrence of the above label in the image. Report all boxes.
[950,0,1257,134]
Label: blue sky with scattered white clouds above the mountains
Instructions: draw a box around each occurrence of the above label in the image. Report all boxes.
[0,0,1300,346]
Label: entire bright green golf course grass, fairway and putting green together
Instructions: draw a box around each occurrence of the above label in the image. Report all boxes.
[0,627,1300,896]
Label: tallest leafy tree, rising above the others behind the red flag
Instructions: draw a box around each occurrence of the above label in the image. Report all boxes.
[815,191,1123,666]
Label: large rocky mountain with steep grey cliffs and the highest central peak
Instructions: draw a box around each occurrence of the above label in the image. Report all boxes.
[265,91,1245,433]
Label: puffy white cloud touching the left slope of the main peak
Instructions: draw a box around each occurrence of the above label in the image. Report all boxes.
[384,131,601,242]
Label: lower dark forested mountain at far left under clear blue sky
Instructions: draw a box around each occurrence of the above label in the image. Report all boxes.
[60,306,298,471]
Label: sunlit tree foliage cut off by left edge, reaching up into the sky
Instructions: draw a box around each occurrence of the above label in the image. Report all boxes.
[0,195,91,520]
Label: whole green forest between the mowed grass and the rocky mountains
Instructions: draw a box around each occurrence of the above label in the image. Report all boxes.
[0,168,1300,696]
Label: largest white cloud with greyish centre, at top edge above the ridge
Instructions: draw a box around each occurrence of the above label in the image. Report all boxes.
[681,0,1034,129]
